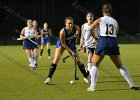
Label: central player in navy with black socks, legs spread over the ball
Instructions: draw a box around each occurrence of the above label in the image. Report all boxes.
[44,17,89,84]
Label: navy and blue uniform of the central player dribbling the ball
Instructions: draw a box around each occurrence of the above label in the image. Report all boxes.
[56,26,76,51]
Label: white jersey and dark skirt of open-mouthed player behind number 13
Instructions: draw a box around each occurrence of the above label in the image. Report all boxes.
[81,23,99,53]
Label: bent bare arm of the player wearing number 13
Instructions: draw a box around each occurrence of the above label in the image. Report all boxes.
[89,19,100,40]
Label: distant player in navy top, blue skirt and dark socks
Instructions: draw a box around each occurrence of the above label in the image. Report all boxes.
[39,23,52,59]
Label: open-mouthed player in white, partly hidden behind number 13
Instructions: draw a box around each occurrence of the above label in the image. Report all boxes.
[80,12,99,76]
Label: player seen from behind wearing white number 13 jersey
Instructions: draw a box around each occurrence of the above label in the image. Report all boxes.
[87,4,139,91]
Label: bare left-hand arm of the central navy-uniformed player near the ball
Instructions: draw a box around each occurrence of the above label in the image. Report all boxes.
[59,29,75,55]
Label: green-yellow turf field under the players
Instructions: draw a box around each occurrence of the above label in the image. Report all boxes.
[0,44,140,100]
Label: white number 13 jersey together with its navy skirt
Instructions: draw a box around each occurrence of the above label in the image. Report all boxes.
[95,16,120,55]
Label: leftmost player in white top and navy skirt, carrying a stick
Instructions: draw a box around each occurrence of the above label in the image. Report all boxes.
[20,19,37,69]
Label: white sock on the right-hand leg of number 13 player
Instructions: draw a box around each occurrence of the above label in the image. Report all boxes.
[120,65,134,85]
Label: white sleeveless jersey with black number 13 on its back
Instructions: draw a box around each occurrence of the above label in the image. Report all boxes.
[100,16,118,37]
